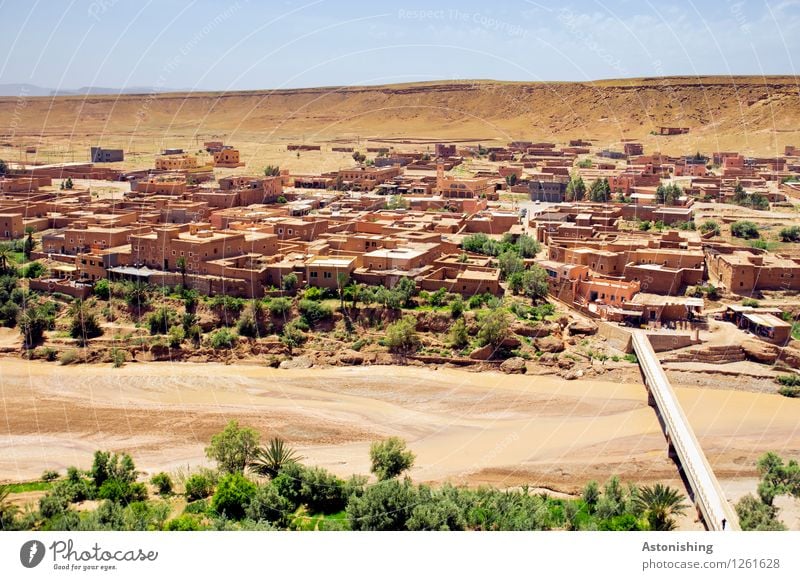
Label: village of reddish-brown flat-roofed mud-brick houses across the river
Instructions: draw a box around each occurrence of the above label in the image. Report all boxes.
[0,139,800,342]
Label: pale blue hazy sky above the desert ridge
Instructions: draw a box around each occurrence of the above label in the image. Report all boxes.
[0,0,800,90]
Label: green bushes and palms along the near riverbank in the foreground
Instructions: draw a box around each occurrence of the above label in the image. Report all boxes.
[7,422,768,531]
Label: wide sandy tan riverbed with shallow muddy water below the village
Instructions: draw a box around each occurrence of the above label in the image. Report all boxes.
[0,359,800,529]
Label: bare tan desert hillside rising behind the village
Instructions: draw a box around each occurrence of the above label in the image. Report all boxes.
[0,77,800,158]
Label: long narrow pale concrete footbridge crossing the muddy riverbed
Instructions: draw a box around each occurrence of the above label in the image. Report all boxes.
[632,330,741,531]
